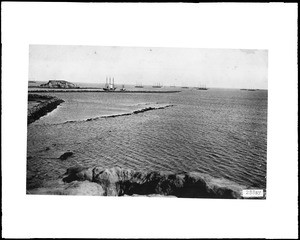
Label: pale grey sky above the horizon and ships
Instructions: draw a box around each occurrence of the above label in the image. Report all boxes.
[29,45,268,89]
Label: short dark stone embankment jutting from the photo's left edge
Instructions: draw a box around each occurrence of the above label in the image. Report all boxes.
[27,94,64,124]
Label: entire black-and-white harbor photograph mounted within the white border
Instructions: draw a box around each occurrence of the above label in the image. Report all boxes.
[26,45,268,199]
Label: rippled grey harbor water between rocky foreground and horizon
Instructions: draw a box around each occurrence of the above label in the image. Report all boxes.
[27,88,268,189]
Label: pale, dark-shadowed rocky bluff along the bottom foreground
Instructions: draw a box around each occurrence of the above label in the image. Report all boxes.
[29,167,246,199]
